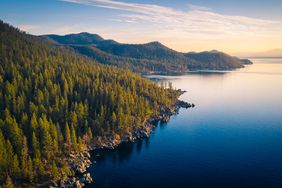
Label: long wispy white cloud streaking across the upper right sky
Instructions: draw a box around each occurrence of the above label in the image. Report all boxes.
[61,0,282,37]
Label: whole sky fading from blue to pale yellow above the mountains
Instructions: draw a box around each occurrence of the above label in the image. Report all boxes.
[0,0,282,55]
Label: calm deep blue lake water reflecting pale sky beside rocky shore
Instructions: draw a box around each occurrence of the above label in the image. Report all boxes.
[88,59,282,188]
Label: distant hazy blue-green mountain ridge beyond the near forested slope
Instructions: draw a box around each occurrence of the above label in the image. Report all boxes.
[40,32,252,73]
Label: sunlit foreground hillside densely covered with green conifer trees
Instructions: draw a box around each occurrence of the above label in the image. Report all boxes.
[0,21,179,184]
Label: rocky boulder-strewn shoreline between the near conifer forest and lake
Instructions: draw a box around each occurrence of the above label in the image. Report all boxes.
[53,90,195,188]
